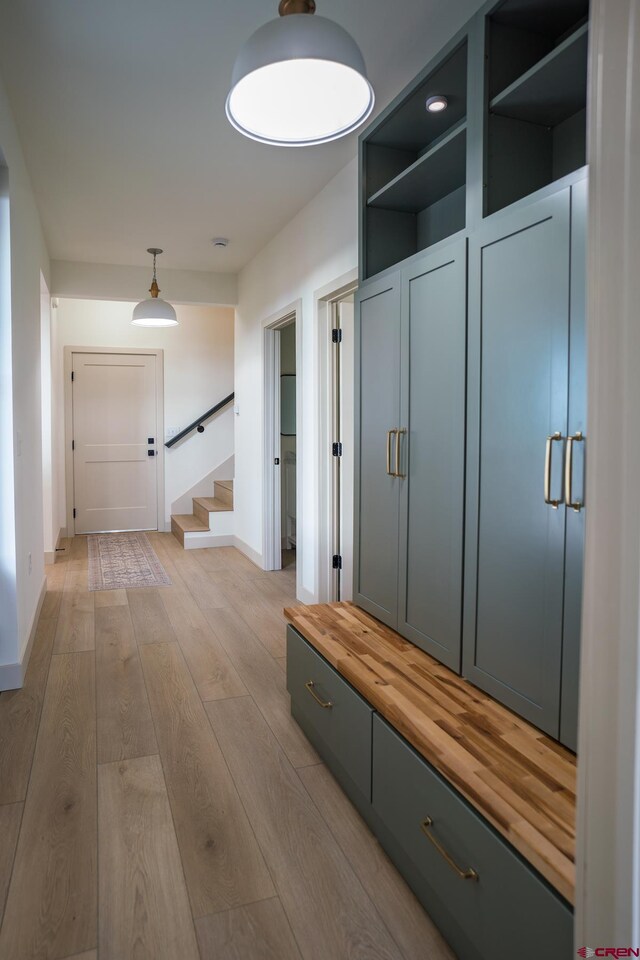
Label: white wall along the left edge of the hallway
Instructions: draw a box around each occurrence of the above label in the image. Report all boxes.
[0,71,49,686]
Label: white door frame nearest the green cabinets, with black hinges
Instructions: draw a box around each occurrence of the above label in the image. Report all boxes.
[313,268,358,603]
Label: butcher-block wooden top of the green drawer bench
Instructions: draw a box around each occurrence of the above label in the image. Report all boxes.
[284,603,576,903]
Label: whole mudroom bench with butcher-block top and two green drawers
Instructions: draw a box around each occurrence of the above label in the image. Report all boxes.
[285,603,576,960]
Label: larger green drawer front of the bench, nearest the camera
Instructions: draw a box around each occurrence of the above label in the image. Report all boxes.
[372,715,573,960]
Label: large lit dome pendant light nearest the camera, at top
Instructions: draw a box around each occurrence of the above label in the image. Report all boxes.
[226,0,375,147]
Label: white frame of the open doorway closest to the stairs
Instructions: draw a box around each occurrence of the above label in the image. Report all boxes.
[261,299,304,596]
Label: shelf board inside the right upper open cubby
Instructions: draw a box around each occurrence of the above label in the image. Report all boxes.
[489,23,589,127]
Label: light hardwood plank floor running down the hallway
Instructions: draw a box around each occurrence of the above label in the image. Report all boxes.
[0,534,452,960]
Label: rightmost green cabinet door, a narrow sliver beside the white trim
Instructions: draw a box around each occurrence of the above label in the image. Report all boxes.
[560,180,587,750]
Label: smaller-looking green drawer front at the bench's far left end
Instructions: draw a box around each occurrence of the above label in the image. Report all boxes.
[287,627,373,800]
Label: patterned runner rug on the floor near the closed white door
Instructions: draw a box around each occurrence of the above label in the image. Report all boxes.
[87,533,171,590]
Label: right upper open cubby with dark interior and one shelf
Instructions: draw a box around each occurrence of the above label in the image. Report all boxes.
[484,0,589,216]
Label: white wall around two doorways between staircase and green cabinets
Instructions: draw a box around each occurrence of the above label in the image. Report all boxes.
[234,159,358,600]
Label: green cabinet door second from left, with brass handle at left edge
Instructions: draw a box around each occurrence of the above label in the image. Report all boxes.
[398,240,467,671]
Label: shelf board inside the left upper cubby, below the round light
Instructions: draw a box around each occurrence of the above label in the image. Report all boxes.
[367,120,467,213]
